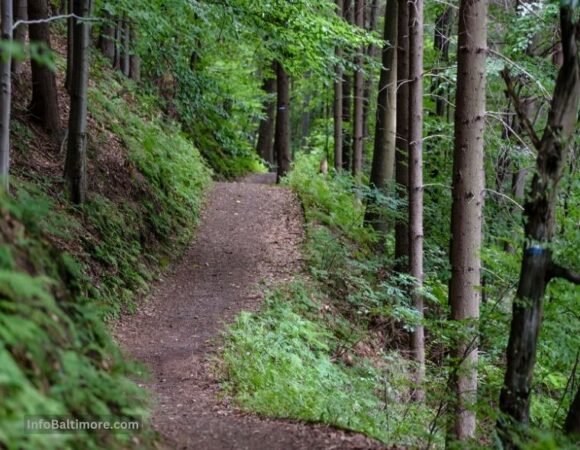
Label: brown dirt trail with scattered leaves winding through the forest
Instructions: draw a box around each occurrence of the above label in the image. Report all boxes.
[115,175,379,450]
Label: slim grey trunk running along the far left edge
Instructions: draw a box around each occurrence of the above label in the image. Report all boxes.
[0,0,14,192]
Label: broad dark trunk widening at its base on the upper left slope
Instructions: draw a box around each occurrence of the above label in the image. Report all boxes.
[28,0,61,141]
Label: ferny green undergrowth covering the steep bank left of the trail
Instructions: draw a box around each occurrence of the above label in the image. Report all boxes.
[0,51,211,449]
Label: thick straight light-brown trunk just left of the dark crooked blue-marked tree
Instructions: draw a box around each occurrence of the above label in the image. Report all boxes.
[449,0,487,441]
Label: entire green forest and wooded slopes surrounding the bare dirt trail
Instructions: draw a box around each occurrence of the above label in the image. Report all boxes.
[0,0,580,449]
